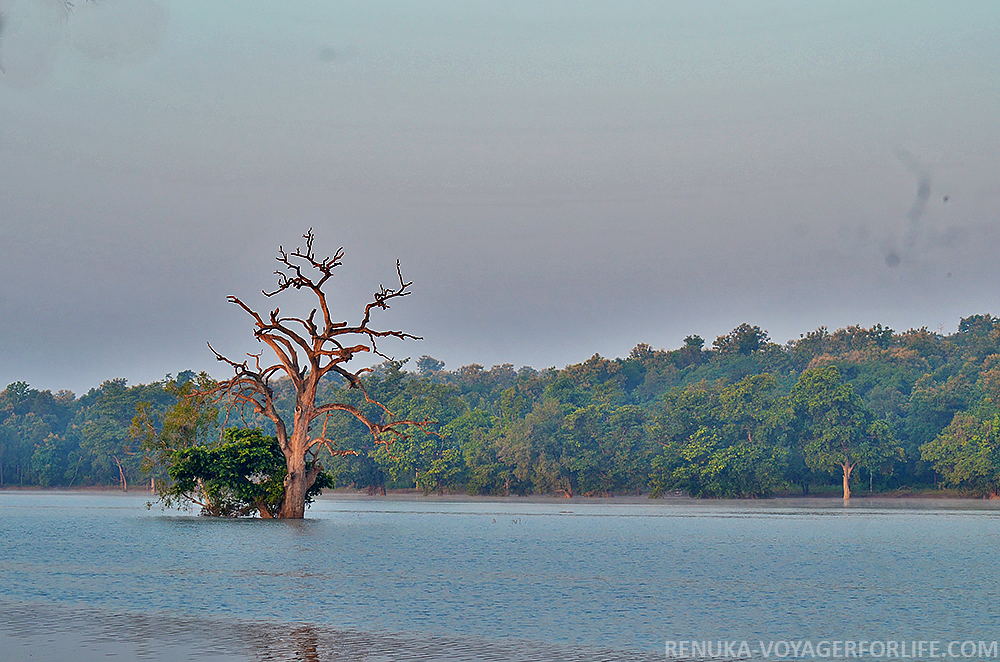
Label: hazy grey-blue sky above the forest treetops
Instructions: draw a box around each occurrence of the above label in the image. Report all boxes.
[0,0,1000,393]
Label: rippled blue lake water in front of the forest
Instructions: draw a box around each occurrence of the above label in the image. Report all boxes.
[0,492,1000,662]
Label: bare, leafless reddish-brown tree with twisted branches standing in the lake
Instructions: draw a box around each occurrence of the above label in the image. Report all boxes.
[201,229,431,519]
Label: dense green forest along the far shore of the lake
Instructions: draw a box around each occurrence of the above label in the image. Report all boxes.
[0,314,1000,498]
